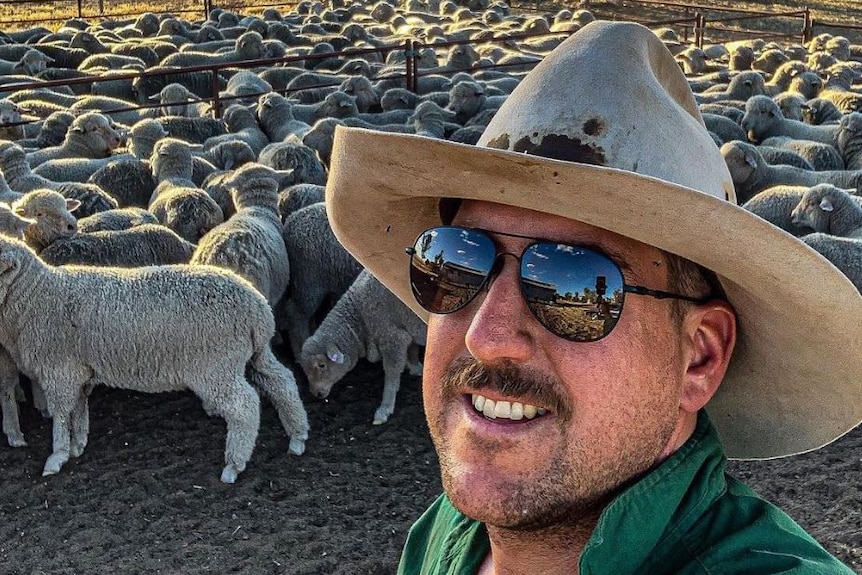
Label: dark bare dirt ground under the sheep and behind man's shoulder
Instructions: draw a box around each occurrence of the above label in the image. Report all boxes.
[0,354,862,575]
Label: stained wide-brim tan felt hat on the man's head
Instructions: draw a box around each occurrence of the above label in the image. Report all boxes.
[326,21,862,459]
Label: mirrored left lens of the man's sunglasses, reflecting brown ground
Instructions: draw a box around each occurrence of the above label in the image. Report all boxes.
[410,227,495,313]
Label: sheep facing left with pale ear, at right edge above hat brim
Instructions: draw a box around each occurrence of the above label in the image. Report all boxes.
[790,184,862,239]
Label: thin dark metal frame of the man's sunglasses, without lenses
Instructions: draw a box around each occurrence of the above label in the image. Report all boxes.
[404,225,715,343]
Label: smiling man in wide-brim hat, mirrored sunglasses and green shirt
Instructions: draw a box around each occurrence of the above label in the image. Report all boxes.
[327,22,862,575]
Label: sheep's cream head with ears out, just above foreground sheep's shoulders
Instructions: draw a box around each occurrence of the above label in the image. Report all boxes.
[12,190,81,253]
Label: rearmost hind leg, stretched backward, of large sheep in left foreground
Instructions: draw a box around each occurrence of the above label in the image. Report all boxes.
[248,347,308,455]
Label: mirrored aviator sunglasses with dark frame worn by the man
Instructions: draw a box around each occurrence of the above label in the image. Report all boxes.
[406,226,712,342]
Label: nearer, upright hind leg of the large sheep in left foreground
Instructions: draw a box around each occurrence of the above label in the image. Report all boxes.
[192,375,260,483]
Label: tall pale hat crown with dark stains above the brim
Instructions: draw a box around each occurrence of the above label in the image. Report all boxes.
[478,21,735,202]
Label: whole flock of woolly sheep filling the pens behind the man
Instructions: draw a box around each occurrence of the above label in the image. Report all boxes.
[0,0,862,483]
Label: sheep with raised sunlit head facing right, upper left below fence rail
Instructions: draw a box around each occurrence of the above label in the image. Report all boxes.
[27,112,122,168]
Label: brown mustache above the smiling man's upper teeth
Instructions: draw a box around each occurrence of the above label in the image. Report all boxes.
[440,358,572,419]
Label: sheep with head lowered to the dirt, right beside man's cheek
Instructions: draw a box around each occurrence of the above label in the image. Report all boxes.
[300,270,425,425]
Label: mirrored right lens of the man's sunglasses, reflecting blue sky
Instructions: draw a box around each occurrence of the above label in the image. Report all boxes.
[521,242,623,341]
